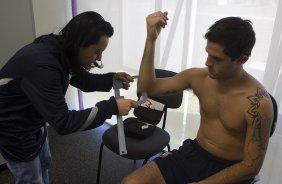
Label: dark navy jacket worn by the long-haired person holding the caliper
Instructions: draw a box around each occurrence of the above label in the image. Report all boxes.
[0,35,117,161]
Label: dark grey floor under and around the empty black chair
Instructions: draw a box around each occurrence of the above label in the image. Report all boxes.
[0,124,145,184]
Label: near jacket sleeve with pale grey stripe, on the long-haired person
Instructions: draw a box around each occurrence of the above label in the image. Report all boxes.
[21,66,117,134]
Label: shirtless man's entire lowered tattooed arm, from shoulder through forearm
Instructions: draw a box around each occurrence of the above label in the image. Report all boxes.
[198,88,273,184]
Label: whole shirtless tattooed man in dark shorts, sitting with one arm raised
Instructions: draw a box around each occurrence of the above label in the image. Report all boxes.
[122,12,273,184]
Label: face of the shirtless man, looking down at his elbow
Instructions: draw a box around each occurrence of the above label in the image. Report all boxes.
[206,41,242,79]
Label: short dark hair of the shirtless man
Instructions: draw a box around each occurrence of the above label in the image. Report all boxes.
[205,17,256,60]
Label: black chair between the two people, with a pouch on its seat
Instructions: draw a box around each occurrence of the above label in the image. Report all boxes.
[96,69,183,184]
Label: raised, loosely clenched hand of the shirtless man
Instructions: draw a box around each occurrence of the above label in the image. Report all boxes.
[146,11,168,41]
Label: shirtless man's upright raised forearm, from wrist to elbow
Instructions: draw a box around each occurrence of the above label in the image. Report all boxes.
[137,38,156,92]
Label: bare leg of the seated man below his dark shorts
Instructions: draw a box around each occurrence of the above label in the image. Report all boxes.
[122,161,166,184]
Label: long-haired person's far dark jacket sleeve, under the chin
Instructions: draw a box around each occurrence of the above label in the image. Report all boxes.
[70,69,114,92]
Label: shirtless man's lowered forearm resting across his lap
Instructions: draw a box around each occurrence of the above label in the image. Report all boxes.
[198,162,257,184]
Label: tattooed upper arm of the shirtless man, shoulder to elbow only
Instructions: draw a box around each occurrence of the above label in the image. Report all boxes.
[245,88,273,171]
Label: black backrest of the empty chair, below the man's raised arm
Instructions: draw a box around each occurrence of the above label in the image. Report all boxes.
[133,69,183,129]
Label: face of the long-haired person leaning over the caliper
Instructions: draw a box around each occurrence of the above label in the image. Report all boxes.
[79,36,109,67]
